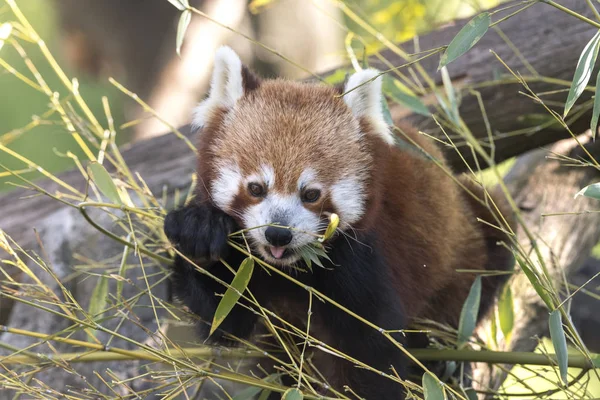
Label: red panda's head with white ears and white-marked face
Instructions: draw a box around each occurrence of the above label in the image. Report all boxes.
[193,47,393,265]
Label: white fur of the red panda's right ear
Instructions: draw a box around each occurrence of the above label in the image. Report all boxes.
[344,69,394,144]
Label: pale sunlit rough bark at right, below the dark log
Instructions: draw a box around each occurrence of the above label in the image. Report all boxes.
[476,135,600,391]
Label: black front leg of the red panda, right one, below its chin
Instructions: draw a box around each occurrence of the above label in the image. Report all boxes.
[315,238,408,400]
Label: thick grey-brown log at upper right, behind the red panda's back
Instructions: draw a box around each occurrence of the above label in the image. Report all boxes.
[325,0,597,171]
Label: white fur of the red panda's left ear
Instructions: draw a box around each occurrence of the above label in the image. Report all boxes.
[192,46,244,128]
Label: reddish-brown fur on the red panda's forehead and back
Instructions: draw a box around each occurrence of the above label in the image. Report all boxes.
[198,77,505,325]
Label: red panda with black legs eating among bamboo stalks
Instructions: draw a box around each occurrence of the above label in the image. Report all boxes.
[164,47,511,400]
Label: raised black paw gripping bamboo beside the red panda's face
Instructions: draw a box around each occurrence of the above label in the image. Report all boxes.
[164,204,236,261]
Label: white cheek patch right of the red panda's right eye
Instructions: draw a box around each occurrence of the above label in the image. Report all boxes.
[331,178,366,224]
